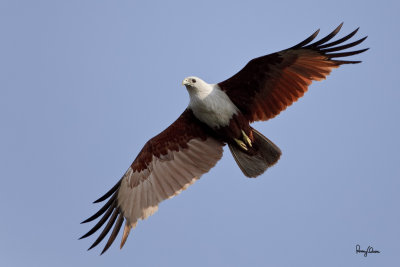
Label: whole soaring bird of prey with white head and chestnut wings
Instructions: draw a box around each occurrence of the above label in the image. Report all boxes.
[81,23,368,254]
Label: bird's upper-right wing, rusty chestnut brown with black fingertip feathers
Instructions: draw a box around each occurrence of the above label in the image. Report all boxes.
[218,23,368,122]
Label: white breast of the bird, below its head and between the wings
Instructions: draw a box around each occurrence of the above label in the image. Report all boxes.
[189,84,238,128]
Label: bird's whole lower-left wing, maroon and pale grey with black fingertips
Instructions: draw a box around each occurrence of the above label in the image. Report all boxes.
[81,109,224,254]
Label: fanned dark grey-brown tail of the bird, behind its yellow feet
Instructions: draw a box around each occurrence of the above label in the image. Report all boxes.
[228,128,282,178]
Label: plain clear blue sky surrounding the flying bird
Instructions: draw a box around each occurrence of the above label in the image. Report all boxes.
[0,0,400,267]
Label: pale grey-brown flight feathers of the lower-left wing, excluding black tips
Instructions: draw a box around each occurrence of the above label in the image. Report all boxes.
[118,138,223,247]
